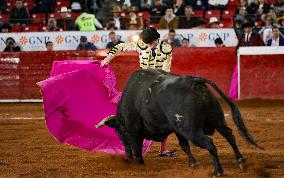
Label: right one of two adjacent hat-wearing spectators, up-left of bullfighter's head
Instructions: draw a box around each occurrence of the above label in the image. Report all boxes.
[126,7,144,30]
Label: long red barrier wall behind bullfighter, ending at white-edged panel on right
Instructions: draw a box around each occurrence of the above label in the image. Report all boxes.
[0,47,242,99]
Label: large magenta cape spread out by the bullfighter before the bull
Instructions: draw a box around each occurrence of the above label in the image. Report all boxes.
[38,60,151,155]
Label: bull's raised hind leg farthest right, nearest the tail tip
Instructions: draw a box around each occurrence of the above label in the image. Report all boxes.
[216,124,245,170]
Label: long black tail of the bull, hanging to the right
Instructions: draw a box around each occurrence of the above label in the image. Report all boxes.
[196,78,263,150]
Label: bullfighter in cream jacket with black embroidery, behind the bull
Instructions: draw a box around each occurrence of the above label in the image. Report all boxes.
[101,27,175,157]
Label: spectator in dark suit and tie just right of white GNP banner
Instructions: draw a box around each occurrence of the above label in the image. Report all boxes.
[238,22,264,47]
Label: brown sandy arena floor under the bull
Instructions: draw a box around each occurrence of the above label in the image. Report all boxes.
[0,100,284,178]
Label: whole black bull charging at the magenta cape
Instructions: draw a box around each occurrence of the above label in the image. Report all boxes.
[97,70,258,176]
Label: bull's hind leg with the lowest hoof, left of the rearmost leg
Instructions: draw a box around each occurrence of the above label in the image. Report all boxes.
[189,131,223,176]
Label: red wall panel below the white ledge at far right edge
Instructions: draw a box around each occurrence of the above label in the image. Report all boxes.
[240,55,284,99]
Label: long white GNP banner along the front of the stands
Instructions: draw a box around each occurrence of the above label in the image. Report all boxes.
[0,29,238,51]
